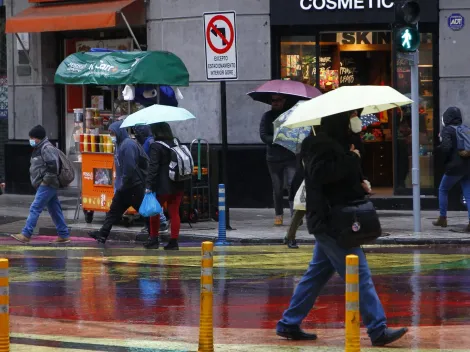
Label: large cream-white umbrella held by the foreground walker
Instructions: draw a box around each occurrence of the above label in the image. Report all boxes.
[283,86,413,128]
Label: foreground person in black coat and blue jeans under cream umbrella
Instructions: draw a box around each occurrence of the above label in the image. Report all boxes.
[276,113,407,346]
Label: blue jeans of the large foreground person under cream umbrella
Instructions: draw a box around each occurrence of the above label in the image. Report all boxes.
[279,234,387,341]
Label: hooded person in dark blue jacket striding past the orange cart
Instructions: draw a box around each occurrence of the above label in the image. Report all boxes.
[89,121,148,243]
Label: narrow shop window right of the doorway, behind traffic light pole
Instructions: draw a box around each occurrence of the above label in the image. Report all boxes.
[396,33,434,193]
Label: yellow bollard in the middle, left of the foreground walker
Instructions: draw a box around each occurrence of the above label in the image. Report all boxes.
[198,242,214,352]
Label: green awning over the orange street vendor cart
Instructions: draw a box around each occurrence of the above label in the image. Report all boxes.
[54,51,189,86]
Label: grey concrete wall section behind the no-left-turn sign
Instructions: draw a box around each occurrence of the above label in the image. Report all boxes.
[147,0,271,144]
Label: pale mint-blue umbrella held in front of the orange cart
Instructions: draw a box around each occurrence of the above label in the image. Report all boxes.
[121,104,196,128]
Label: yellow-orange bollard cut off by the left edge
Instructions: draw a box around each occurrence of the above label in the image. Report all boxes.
[0,259,10,352]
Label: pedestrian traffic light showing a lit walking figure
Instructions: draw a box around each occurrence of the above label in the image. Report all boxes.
[394,0,421,52]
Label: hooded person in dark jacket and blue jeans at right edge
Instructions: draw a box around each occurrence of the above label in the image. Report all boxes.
[432,107,470,232]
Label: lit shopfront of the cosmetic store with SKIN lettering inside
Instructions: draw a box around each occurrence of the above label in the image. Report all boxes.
[280,31,434,195]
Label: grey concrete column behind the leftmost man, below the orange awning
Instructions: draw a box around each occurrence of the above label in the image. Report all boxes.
[5,0,59,140]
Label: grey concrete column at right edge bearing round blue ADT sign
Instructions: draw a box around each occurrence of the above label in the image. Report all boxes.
[439,0,470,124]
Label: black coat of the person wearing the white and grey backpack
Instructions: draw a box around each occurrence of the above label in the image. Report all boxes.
[145,141,184,196]
